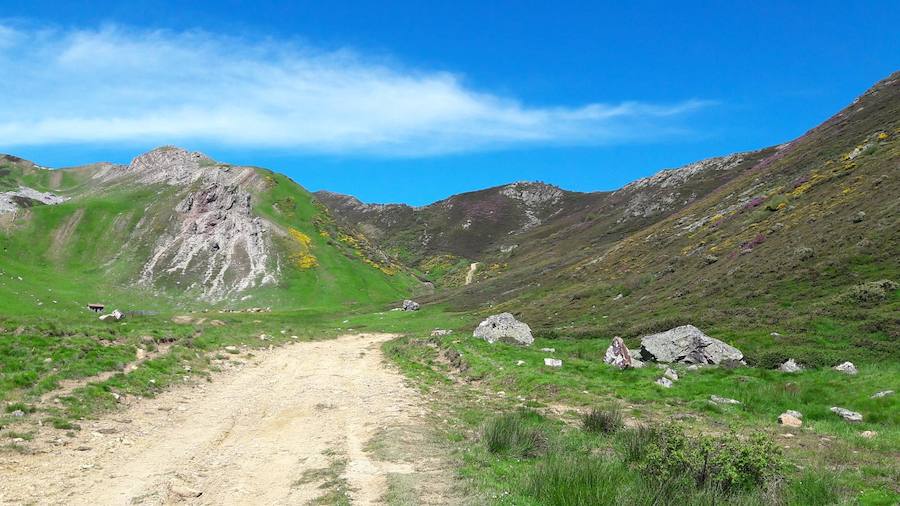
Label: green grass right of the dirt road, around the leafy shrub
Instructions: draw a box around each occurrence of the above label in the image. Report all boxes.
[384,314,900,505]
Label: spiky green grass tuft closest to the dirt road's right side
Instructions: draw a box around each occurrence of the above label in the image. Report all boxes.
[482,410,547,457]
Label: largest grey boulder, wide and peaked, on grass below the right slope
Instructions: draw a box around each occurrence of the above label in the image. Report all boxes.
[641,325,744,364]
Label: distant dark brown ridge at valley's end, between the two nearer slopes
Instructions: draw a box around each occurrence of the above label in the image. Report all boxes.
[316,150,771,287]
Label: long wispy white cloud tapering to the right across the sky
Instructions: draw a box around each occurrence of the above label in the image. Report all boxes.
[0,24,709,156]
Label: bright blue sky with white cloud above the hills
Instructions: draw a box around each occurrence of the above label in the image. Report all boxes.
[0,0,900,205]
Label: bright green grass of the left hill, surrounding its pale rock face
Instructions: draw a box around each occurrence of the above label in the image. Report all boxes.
[0,150,418,315]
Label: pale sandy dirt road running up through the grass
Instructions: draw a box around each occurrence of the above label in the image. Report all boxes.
[0,334,454,505]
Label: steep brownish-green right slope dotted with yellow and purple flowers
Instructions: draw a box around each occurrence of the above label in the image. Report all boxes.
[450,70,900,363]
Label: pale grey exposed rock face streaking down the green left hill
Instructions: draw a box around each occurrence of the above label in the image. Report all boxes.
[139,182,279,300]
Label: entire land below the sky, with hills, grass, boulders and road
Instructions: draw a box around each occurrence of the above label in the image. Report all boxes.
[0,73,900,505]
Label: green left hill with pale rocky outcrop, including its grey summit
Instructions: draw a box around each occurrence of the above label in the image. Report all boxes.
[0,148,418,313]
